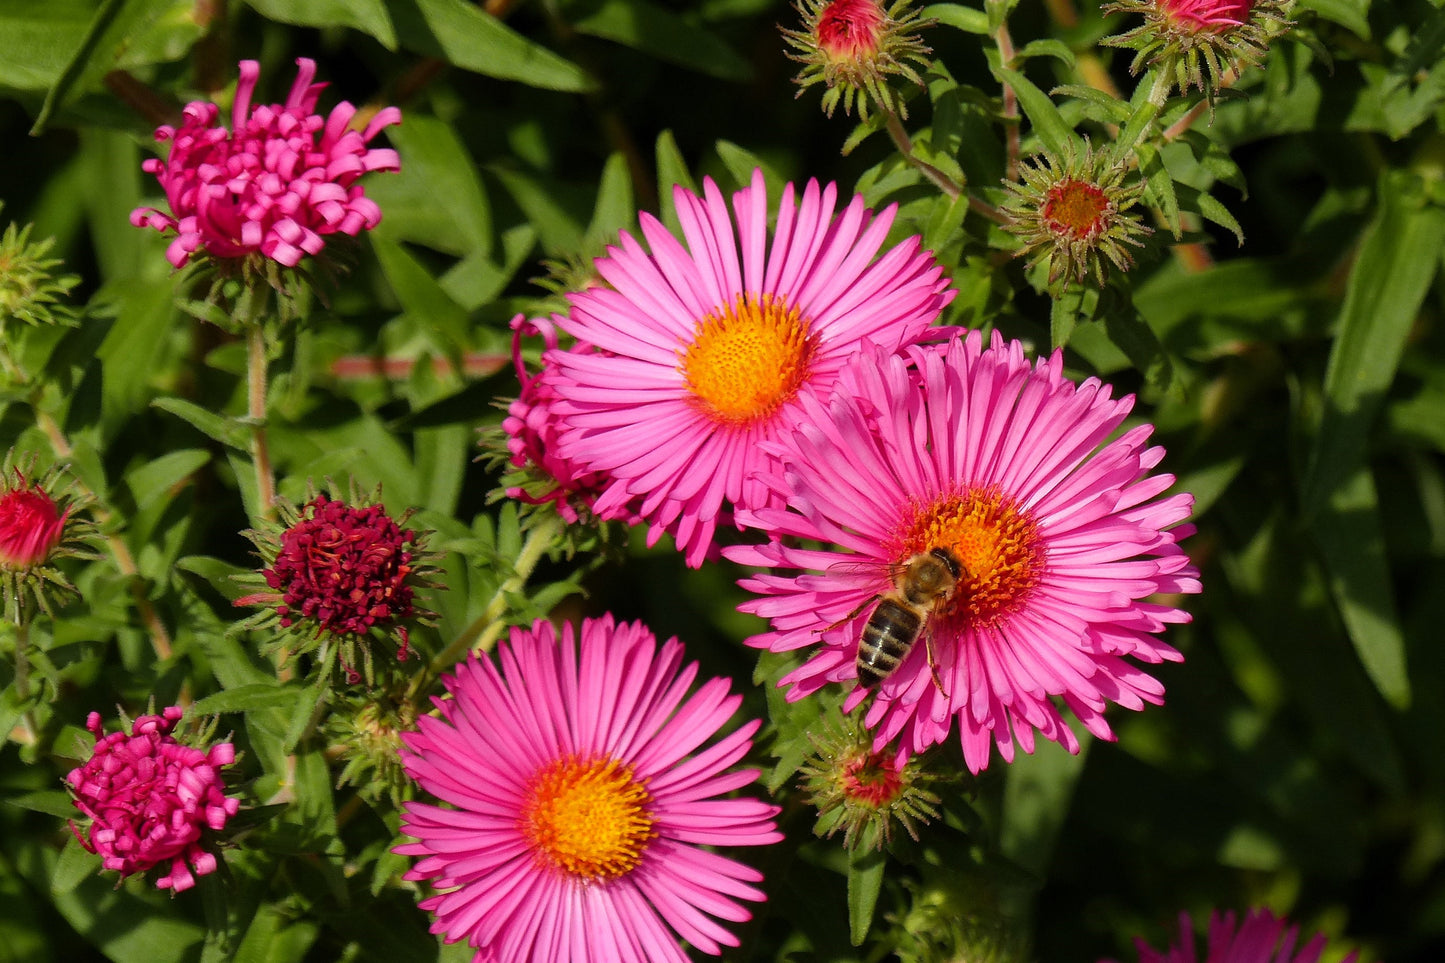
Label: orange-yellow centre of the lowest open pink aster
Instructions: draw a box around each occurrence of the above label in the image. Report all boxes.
[519,758,657,881]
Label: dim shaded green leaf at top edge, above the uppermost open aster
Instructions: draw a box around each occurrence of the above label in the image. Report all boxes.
[572,0,753,81]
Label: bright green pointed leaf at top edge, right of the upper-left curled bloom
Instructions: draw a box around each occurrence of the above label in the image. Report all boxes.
[390,0,597,94]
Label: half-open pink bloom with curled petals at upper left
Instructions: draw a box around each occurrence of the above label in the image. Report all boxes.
[130,58,402,268]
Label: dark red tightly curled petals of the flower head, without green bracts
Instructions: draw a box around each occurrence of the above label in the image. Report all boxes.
[264,495,416,635]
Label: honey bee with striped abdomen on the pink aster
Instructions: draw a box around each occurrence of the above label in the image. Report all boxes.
[845,548,962,697]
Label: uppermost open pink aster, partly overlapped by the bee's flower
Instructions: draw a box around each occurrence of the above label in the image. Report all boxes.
[548,171,952,567]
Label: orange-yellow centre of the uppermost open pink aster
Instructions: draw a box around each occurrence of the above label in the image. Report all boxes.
[678,295,816,428]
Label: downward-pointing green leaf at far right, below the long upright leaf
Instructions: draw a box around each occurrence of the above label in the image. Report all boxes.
[1311,464,1410,710]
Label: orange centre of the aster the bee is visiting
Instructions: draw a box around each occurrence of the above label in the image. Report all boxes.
[899,489,1046,626]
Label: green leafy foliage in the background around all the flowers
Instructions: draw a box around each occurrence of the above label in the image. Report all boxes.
[0,0,1445,963]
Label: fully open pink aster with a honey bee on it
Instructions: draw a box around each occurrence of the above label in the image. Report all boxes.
[724,331,1199,772]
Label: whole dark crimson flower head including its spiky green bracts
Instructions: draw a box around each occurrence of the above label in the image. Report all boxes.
[233,483,439,684]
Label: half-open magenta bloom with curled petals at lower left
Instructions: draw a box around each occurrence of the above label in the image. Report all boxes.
[65,706,240,892]
